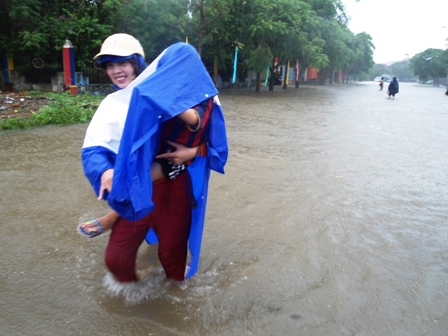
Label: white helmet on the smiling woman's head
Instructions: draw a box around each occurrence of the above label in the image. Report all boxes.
[93,33,145,59]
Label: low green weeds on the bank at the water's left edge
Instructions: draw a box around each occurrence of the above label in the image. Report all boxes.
[0,92,104,130]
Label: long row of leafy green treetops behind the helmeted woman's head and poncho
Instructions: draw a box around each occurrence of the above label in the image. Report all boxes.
[0,0,374,89]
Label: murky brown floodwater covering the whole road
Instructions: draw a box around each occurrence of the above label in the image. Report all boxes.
[0,82,448,336]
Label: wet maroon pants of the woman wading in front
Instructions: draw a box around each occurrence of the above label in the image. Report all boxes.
[105,171,192,282]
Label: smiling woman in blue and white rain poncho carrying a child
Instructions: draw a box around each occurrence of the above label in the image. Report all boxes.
[78,34,227,282]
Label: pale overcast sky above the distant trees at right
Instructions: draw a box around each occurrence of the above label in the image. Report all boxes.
[342,0,448,63]
